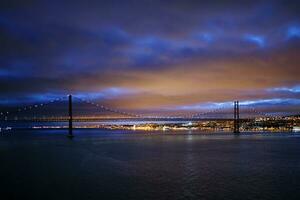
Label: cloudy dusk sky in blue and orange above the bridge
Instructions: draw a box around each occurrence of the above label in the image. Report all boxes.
[0,0,300,114]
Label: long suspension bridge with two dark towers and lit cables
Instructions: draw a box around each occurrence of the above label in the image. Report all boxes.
[0,95,299,137]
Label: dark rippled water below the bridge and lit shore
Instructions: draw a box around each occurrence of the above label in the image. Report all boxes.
[0,130,300,200]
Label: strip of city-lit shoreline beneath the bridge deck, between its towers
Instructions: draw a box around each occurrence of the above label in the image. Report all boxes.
[0,116,300,132]
